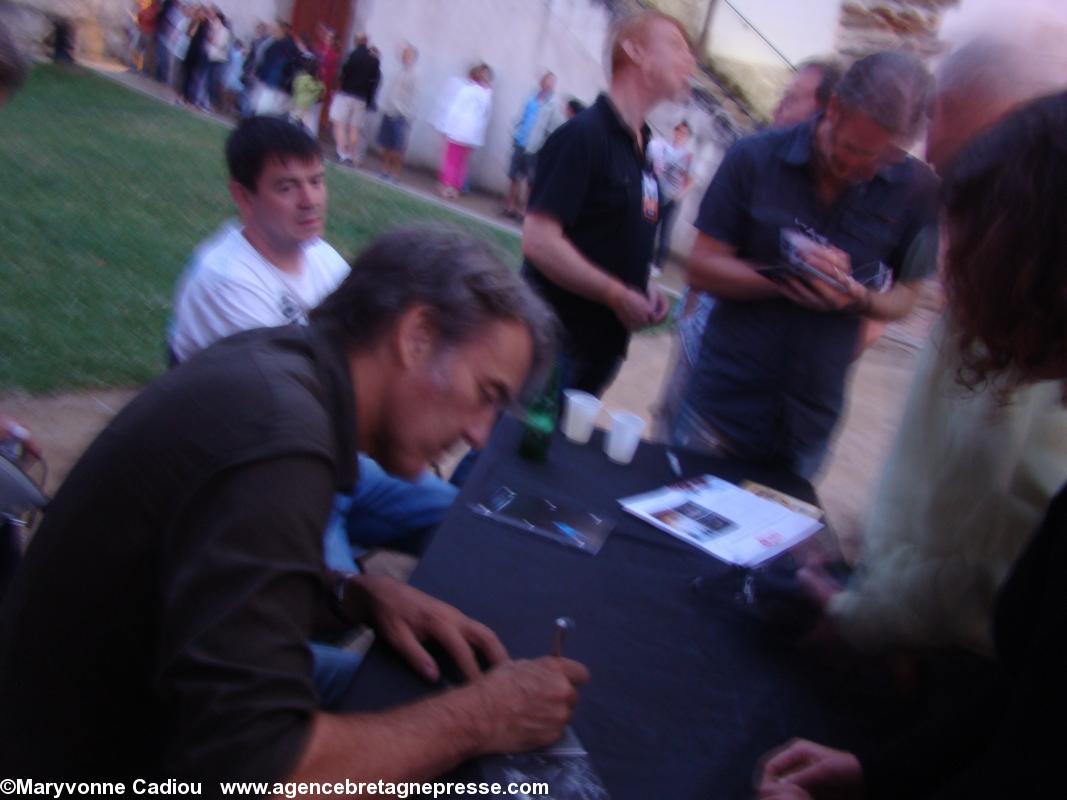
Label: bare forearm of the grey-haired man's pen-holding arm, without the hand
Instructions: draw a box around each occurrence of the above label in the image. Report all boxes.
[287,686,488,782]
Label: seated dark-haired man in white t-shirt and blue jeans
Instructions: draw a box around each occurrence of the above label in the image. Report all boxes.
[169,116,456,588]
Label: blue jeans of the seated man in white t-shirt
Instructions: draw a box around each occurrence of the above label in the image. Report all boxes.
[323,453,459,572]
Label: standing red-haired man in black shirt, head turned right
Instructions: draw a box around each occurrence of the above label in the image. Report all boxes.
[523,12,695,395]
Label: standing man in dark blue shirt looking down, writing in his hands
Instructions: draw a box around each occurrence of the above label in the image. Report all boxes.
[669,52,937,477]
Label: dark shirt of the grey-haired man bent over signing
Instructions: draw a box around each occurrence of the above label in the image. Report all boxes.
[0,325,356,794]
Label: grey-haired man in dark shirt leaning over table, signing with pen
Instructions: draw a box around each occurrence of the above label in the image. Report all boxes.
[0,224,587,796]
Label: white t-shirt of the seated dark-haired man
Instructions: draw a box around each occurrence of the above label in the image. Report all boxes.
[170,222,349,362]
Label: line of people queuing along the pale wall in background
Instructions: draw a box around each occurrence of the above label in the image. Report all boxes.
[128,0,601,201]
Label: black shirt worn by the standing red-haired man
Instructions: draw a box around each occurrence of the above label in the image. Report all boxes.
[524,94,657,359]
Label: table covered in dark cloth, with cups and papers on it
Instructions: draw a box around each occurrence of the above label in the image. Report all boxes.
[341,418,898,800]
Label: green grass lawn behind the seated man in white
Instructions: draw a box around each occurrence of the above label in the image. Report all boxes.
[0,66,520,394]
